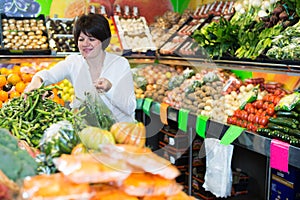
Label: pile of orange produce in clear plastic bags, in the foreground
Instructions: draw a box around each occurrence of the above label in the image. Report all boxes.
[21,144,194,200]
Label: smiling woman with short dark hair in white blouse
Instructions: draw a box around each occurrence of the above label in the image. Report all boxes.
[25,13,136,122]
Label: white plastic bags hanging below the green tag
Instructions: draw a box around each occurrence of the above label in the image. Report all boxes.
[203,138,233,198]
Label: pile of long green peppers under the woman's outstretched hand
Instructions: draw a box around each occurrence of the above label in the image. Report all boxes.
[0,86,80,148]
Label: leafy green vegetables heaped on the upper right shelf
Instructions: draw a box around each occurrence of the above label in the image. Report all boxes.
[192,0,299,59]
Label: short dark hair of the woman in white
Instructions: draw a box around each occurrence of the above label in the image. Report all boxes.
[73,13,111,50]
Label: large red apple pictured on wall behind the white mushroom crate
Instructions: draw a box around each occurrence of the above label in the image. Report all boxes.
[114,0,173,24]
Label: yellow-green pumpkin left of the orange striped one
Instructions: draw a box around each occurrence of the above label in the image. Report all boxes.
[78,126,115,150]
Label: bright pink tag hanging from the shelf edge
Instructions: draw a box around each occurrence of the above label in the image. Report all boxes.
[270,139,290,172]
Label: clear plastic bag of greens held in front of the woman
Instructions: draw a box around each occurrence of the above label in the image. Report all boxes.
[79,92,116,130]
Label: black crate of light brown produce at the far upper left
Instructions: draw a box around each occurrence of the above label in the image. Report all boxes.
[1,14,49,54]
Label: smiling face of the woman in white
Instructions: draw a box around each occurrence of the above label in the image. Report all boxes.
[78,32,103,59]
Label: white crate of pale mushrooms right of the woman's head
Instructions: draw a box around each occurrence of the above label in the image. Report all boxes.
[113,6,156,53]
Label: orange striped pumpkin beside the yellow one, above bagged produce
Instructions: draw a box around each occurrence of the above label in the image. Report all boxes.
[110,122,146,147]
